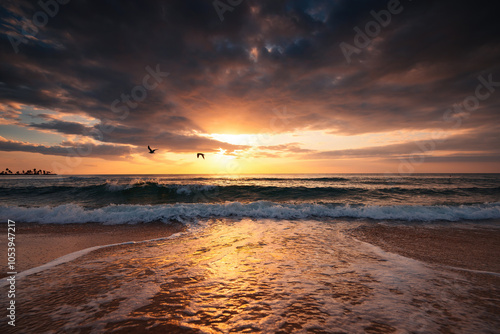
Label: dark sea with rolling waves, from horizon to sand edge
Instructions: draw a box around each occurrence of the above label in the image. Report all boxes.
[0,174,500,223]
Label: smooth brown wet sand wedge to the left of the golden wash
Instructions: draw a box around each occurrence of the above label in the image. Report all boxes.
[0,222,183,277]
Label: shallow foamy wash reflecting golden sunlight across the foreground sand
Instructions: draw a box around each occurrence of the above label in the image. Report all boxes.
[2,219,500,333]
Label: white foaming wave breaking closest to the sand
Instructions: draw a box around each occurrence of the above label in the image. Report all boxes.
[0,201,500,224]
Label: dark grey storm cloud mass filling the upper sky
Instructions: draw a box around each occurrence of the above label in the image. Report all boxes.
[0,0,500,158]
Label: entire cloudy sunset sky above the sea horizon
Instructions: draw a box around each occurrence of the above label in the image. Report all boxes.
[0,0,500,175]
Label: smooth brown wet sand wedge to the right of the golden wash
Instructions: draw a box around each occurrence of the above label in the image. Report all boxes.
[350,224,500,273]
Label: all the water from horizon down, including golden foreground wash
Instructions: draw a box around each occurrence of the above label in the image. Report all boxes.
[0,174,500,333]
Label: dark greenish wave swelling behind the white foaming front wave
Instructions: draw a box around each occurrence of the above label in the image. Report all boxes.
[0,178,500,208]
